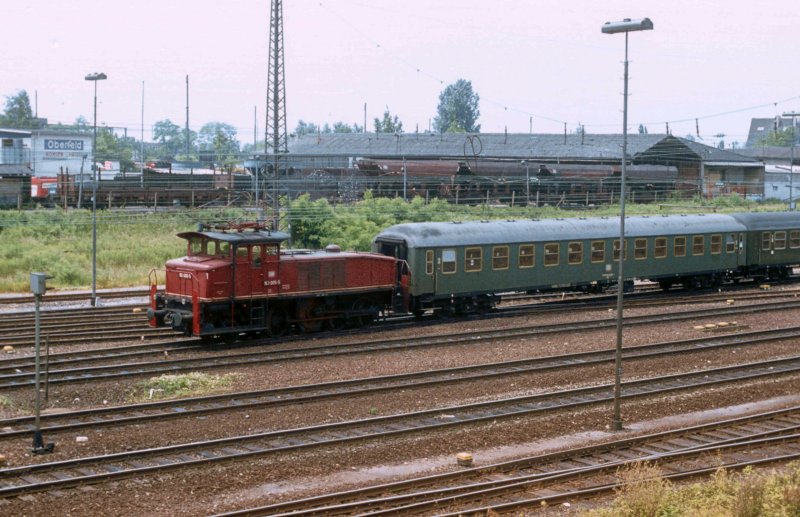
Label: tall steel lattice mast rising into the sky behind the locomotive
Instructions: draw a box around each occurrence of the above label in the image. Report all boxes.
[264,0,289,215]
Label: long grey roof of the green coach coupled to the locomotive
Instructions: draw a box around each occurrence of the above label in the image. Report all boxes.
[375,214,747,247]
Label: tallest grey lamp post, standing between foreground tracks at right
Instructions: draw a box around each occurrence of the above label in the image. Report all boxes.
[600,18,653,431]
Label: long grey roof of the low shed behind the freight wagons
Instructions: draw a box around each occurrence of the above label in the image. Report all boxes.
[289,133,758,165]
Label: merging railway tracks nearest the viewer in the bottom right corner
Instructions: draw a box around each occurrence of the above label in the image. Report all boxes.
[223,407,800,517]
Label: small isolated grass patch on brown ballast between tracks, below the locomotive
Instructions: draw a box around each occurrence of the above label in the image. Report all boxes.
[132,372,240,402]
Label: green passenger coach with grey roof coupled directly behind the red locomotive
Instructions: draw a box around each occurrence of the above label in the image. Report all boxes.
[373,214,752,314]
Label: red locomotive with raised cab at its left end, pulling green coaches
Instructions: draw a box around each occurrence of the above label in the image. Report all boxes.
[147,223,410,336]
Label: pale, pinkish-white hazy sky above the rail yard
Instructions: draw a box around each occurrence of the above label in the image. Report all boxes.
[0,0,800,144]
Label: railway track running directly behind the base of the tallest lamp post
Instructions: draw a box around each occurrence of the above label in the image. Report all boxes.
[0,356,800,498]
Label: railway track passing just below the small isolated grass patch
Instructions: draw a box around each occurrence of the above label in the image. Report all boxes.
[0,327,800,439]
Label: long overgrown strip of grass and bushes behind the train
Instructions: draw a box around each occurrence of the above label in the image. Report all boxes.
[0,196,785,292]
